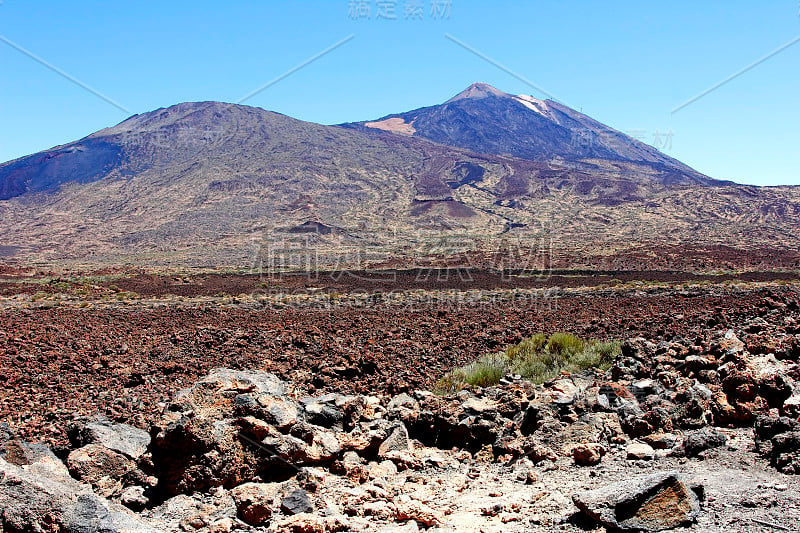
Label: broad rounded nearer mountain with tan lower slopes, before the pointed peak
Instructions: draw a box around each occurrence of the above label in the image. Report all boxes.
[0,96,800,268]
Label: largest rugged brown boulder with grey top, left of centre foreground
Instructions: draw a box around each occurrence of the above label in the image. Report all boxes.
[151,369,310,495]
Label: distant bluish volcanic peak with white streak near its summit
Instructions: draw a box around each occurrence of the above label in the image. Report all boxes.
[343,83,720,185]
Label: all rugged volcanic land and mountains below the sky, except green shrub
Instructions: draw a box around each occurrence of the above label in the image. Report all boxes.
[0,84,800,533]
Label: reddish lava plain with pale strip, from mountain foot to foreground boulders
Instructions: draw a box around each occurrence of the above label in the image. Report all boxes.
[0,271,796,443]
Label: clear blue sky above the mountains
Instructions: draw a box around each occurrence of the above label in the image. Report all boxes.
[0,0,800,185]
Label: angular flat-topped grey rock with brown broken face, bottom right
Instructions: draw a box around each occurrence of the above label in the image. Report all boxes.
[572,472,701,531]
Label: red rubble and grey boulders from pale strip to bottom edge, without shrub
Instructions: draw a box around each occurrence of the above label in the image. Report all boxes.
[0,272,800,532]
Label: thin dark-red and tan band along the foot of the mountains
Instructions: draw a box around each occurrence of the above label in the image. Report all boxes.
[0,268,798,297]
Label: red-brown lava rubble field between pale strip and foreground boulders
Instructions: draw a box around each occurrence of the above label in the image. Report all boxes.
[0,287,798,442]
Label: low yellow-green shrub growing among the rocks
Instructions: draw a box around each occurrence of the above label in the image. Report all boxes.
[436,332,620,394]
